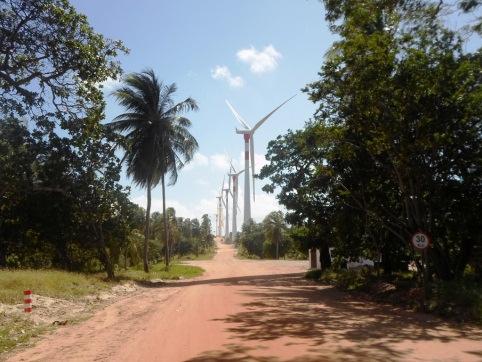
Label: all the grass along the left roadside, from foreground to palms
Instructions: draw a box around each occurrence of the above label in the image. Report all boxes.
[0,264,204,359]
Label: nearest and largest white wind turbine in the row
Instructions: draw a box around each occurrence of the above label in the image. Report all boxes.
[226,95,295,222]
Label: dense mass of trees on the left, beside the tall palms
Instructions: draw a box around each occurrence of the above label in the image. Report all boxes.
[0,0,207,278]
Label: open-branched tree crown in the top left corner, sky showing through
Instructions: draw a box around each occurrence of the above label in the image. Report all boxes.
[0,0,127,122]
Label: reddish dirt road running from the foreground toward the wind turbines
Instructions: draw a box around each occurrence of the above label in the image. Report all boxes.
[10,240,482,362]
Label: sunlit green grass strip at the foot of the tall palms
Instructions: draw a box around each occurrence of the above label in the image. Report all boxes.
[118,263,204,281]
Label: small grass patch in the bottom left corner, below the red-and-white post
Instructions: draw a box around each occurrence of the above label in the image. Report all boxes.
[0,314,51,356]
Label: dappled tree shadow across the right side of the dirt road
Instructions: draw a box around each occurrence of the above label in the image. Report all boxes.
[178,274,482,362]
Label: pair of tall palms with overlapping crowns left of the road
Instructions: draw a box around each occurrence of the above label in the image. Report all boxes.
[108,70,198,273]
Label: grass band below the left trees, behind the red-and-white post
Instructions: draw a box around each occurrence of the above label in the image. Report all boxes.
[0,270,113,304]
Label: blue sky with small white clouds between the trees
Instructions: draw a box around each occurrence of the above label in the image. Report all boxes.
[73,0,334,225]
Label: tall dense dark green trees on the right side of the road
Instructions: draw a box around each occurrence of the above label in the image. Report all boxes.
[260,0,482,279]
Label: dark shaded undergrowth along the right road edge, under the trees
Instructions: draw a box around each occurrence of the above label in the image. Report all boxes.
[305,269,482,324]
